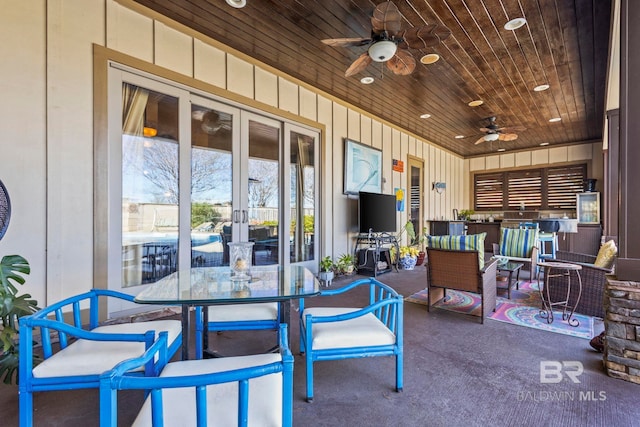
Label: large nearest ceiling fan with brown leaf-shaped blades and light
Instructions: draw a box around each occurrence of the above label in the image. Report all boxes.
[322,1,451,77]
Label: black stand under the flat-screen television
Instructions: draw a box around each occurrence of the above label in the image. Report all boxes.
[354,232,400,277]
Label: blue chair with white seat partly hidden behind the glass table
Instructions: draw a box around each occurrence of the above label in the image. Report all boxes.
[196,302,280,358]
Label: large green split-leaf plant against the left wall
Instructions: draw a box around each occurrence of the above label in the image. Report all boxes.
[0,255,38,384]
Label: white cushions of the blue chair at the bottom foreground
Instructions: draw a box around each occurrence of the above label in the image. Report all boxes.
[133,353,282,427]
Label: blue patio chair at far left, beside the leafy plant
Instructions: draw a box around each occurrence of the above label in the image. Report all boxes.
[18,289,182,427]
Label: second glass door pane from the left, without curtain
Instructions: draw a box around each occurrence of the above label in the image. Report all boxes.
[191,102,238,267]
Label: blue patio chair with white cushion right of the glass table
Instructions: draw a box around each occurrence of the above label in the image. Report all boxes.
[300,278,403,402]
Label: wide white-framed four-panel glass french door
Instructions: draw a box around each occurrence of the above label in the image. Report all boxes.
[108,67,319,313]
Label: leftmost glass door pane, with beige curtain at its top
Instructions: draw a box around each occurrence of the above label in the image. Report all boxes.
[121,83,179,288]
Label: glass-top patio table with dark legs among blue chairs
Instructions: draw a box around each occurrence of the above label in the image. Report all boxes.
[135,265,320,360]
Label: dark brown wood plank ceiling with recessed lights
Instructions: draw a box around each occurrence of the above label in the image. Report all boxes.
[135,0,611,157]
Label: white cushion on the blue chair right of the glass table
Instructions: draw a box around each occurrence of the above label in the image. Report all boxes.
[302,307,396,350]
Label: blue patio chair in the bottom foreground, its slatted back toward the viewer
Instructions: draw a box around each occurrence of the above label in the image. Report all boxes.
[100,324,293,427]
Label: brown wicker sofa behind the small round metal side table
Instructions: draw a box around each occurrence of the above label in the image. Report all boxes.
[549,251,613,318]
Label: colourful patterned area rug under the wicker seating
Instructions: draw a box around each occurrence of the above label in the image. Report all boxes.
[405,281,594,339]
